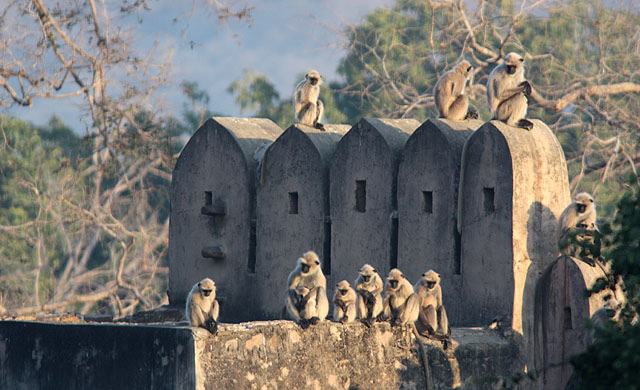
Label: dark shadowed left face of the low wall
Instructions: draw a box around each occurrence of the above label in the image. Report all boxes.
[0,321,196,390]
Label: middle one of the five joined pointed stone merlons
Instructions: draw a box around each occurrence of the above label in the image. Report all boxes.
[330,118,420,281]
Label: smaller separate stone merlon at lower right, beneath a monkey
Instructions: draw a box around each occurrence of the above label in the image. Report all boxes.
[534,256,622,389]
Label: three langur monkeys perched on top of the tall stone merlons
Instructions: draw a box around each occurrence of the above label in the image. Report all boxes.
[293,53,533,130]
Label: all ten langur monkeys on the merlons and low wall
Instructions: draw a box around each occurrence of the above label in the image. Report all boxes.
[186,53,598,339]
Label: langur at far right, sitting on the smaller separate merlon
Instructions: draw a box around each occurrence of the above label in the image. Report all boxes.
[557,192,599,255]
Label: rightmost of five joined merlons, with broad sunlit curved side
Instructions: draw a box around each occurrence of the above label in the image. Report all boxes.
[459,120,570,367]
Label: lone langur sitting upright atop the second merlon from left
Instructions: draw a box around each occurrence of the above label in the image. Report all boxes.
[293,70,324,130]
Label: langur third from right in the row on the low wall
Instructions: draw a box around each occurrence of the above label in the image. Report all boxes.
[353,264,383,327]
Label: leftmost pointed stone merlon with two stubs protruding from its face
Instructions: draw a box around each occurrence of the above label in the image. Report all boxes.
[169,118,282,321]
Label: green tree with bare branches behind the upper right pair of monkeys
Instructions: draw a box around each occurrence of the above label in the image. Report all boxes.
[332,0,640,219]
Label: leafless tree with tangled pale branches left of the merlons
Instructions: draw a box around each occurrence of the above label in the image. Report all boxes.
[0,0,251,317]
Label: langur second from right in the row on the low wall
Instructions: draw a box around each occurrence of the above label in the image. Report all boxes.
[382,268,420,326]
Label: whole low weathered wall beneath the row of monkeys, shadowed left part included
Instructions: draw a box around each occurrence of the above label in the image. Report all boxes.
[0,321,521,390]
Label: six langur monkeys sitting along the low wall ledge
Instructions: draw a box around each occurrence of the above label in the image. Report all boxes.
[186,251,451,340]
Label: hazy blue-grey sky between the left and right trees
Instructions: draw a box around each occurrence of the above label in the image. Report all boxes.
[9,0,394,134]
